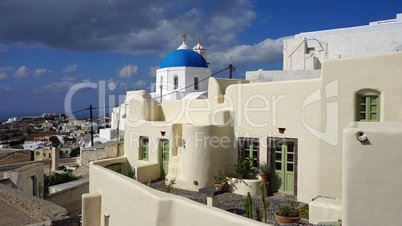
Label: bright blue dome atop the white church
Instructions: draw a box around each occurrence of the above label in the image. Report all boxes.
[160,49,208,69]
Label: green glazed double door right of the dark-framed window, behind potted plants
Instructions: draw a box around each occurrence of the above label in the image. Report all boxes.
[272,141,296,195]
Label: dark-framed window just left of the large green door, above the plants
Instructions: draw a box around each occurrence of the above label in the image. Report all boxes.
[239,138,260,167]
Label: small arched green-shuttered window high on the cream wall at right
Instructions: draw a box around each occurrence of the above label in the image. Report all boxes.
[356,93,381,122]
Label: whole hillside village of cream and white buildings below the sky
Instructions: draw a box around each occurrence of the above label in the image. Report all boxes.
[0,14,402,226]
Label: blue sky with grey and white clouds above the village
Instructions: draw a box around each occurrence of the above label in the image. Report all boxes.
[0,0,402,121]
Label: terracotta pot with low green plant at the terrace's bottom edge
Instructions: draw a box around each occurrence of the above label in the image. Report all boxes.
[275,201,301,224]
